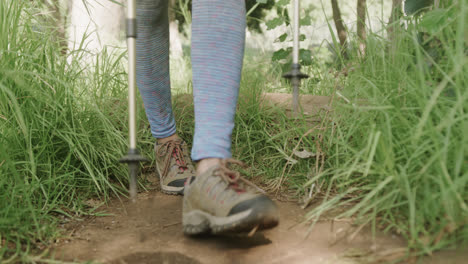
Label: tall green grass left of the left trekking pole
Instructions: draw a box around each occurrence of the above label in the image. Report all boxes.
[0,0,135,263]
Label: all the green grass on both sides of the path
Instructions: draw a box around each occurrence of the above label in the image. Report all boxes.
[0,0,468,263]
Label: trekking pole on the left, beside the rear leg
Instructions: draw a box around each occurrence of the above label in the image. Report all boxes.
[120,0,148,202]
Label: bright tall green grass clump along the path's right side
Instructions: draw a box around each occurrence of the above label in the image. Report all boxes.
[308,1,468,255]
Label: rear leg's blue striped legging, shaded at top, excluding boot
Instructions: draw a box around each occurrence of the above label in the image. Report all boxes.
[136,0,176,139]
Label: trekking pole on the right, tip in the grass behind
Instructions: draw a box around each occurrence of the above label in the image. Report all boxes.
[283,0,309,116]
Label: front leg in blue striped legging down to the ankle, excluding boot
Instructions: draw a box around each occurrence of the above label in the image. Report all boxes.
[192,0,246,172]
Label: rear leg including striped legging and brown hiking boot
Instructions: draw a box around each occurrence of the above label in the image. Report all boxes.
[136,0,194,194]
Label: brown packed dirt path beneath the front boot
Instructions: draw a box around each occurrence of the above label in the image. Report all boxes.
[54,191,404,264]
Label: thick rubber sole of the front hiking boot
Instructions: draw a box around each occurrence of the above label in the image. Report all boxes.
[182,209,279,236]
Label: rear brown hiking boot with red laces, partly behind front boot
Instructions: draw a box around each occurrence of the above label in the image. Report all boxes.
[154,139,195,194]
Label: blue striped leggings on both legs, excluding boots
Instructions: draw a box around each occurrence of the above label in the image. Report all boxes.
[137,0,246,161]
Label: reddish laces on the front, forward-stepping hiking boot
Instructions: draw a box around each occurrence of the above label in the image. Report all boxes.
[215,159,265,193]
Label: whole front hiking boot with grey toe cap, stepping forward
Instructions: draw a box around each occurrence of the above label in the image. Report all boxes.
[182,159,279,235]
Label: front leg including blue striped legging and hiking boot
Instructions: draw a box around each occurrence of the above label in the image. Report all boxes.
[182,0,279,235]
